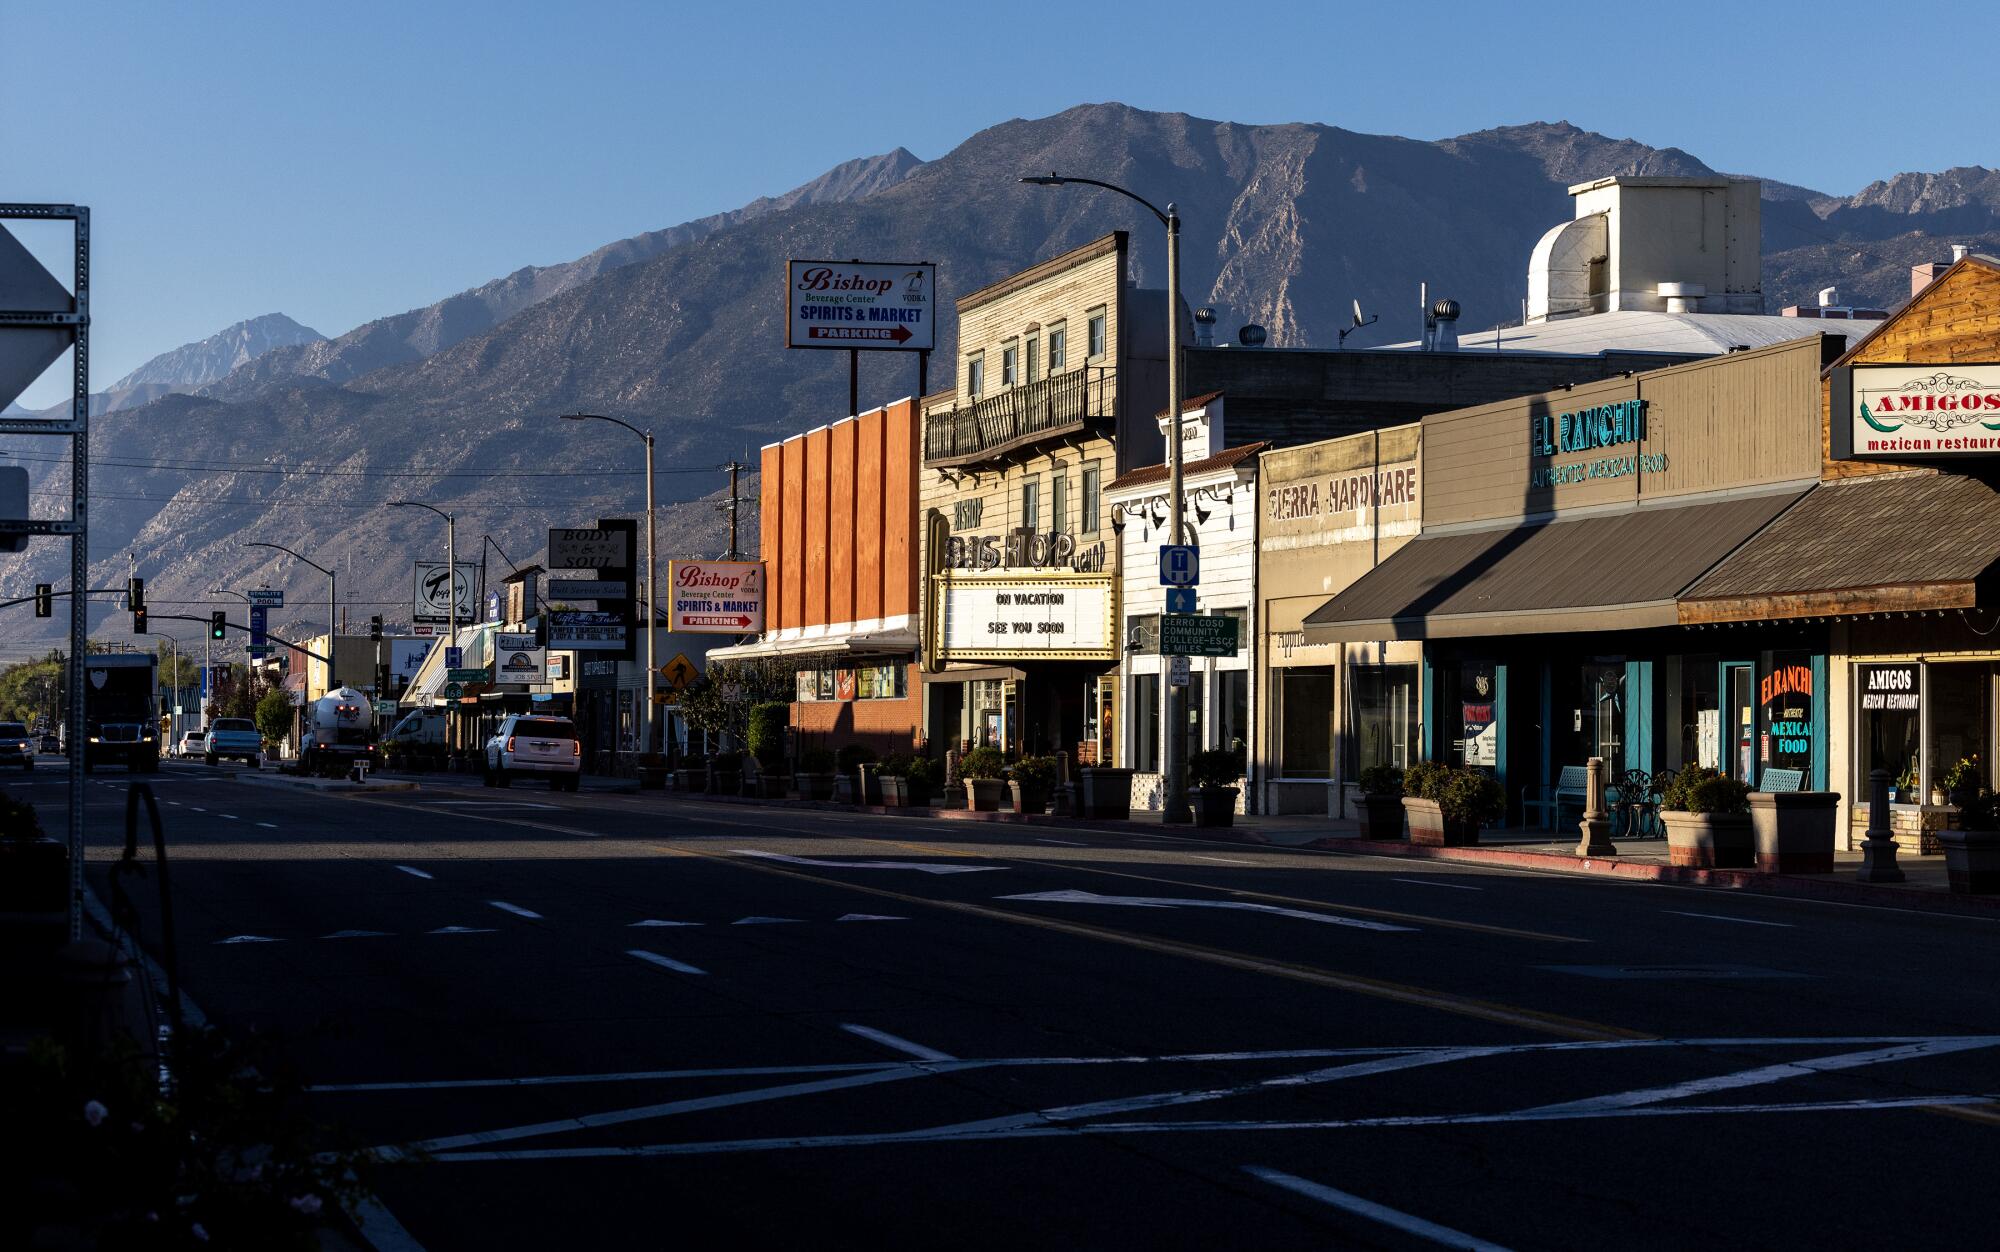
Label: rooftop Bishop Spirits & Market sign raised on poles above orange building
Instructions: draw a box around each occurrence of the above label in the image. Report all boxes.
[784,260,938,352]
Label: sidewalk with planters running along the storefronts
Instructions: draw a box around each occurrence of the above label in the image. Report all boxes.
[662,792,2000,920]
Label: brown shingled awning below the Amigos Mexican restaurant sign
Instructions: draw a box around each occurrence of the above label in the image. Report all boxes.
[1680,472,2000,626]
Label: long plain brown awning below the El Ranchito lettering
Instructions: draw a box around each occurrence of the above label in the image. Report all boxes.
[1306,488,1802,644]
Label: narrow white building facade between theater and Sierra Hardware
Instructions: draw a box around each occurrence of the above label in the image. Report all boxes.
[1104,396,1262,810]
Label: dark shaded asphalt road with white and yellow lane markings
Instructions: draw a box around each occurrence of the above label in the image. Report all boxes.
[23,764,2000,1250]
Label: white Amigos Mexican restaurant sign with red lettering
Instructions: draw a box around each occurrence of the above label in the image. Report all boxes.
[1830,364,2000,460]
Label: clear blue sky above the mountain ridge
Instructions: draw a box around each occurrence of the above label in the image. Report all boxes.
[0,0,2000,402]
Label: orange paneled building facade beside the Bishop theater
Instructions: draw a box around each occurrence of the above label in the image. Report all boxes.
[732,400,920,752]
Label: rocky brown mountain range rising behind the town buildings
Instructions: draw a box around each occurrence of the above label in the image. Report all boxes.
[0,104,2000,648]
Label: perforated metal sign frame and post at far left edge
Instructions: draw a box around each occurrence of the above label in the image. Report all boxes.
[0,204,90,940]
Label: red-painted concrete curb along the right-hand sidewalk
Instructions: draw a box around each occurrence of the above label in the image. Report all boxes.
[1306,838,2000,920]
